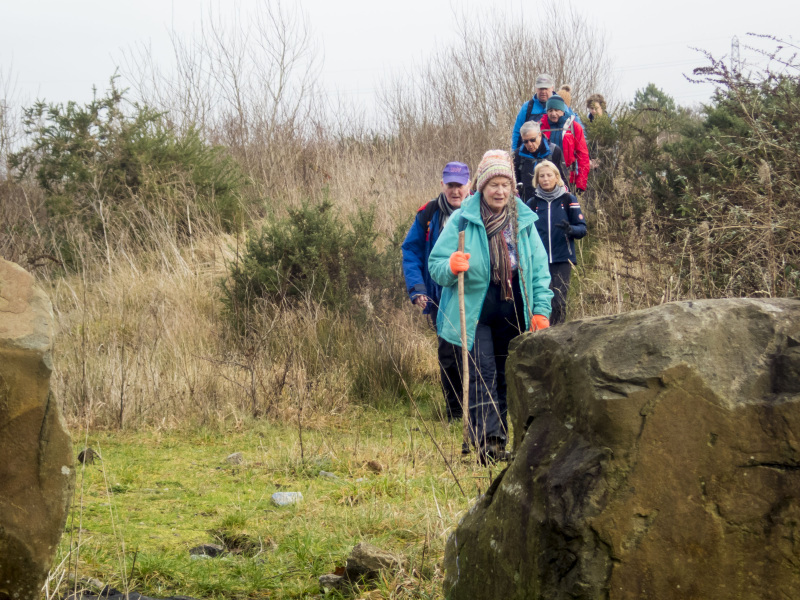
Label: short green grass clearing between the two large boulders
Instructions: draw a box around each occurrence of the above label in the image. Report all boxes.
[60,394,497,598]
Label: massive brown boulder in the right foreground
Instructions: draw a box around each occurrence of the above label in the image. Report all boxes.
[445,299,800,600]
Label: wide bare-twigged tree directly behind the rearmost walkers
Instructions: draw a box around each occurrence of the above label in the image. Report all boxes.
[381,2,612,160]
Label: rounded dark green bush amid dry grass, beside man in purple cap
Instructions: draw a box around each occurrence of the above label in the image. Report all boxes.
[223,200,393,325]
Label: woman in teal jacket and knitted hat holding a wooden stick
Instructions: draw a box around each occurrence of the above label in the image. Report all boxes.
[428,150,553,463]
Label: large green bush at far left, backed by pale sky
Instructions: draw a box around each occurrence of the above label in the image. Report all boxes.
[9,78,244,251]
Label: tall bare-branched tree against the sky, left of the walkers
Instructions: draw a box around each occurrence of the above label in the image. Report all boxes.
[122,0,320,188]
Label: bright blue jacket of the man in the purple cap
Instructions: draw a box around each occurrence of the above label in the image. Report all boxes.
[401,198,446,314]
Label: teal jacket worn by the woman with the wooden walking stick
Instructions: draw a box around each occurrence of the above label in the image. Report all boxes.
[428,192,553,350]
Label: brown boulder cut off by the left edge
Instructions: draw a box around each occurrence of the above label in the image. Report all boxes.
[0,259,74,600]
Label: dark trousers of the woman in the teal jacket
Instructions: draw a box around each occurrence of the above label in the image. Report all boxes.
[456,275,525,449]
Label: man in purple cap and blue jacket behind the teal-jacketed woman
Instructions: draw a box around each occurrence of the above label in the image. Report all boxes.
[402,162,469,421]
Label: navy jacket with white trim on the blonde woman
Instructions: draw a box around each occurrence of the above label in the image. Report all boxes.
[528,193,586,264]
